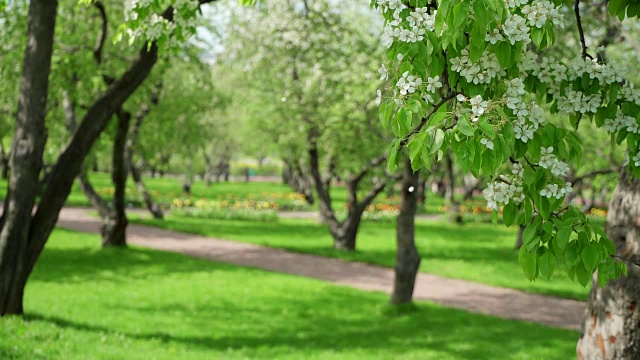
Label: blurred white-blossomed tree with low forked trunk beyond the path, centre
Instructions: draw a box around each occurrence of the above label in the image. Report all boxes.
[228,0,388,251]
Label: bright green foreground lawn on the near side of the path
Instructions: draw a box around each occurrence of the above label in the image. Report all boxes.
[0,230,578,360]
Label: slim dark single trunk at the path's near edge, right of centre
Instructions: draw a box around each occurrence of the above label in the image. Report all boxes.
[390,160,420,305]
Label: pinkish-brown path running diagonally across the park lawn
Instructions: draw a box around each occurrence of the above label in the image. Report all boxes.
[58,208,585,330]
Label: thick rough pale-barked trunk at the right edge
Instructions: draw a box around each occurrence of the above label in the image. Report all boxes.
[577,170,640,360]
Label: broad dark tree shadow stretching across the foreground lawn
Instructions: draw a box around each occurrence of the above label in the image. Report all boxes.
[27,290,577,359]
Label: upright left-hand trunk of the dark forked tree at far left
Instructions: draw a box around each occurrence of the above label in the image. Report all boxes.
[0,0,58,316]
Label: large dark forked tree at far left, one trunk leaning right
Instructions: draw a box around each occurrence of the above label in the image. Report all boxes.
[0,0,218,315]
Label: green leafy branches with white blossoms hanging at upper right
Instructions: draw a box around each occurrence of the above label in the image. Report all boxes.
[372,0,640,358]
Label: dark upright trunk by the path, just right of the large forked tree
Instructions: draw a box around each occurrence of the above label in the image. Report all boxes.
[101,110,131,247]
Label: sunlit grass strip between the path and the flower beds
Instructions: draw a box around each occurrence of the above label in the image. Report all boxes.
[134,216,588,300]
